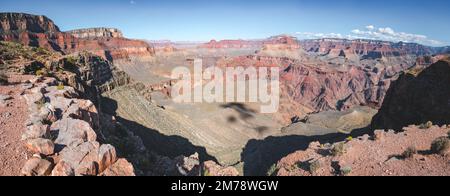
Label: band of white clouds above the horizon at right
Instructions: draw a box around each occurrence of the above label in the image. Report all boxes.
[296,25,445,46]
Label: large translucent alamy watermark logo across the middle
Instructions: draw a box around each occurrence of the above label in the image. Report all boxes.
[171,59,280,113]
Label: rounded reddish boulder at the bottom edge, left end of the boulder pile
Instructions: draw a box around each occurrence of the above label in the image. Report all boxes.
[21,157,53,176]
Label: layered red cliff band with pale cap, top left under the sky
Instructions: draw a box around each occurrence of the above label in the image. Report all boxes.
[0,13,155,61]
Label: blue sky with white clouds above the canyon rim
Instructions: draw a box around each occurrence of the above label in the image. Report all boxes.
[0,0,450,46]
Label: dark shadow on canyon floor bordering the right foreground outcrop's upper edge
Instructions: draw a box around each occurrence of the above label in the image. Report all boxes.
[241,128,371,176]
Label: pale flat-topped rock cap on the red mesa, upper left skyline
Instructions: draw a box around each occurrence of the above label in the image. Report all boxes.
[66,28,124,39]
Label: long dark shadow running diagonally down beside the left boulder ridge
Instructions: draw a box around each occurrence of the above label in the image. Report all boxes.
[101,97,217,162]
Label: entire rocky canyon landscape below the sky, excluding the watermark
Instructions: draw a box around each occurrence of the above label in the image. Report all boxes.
[0,13,450,176]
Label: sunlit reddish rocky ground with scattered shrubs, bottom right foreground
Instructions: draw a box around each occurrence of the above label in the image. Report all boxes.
[270,126,450,176]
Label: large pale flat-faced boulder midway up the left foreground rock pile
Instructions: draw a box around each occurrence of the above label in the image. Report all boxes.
[50,118,97,146]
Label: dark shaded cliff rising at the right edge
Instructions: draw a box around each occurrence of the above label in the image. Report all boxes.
[372,59,450,130]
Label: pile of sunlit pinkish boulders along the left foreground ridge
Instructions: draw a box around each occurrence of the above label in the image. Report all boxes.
[22,77,135,176]
